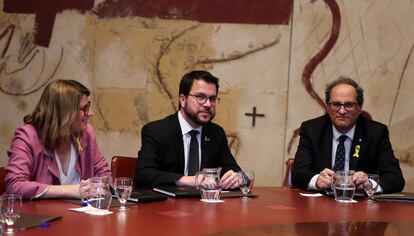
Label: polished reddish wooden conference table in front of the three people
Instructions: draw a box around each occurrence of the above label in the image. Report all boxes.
[14,187,414,236]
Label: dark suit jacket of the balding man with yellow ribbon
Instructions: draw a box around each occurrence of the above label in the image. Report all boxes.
[292,114,405,193]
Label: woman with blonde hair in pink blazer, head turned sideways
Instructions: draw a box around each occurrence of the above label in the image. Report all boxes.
[6,80,111,199]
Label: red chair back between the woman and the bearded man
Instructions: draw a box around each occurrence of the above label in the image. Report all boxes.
[111,156,138,179]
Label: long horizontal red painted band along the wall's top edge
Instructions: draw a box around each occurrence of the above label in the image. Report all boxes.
[95,0,293,25]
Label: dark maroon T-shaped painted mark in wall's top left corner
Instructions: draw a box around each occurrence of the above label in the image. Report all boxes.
[3,0,94,47]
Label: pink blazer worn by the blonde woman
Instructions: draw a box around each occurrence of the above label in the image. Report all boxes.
[5,124,111,198]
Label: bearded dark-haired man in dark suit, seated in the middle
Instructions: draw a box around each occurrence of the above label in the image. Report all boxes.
[135,71,240,189]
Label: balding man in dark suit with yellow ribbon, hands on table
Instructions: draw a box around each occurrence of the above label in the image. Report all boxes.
[292,76,405,193]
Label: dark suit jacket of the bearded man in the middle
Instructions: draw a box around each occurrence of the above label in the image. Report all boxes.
[135,113,240,187]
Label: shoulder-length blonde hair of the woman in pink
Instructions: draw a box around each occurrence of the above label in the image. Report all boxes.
[23,80,90,150]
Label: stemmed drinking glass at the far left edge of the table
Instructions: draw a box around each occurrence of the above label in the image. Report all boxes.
[1,194,22,234]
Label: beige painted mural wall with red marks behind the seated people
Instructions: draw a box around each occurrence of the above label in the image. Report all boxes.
[0,0,414,191]
